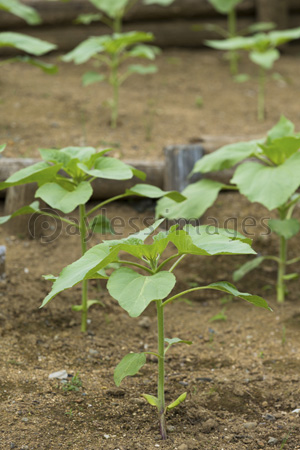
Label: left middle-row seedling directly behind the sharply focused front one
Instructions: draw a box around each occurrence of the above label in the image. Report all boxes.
[0,146,184,331]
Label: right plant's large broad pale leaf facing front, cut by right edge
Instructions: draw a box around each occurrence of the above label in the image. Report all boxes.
[231,153,300,211]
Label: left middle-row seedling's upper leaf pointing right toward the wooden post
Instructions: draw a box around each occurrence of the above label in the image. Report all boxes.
[78,157,133,180]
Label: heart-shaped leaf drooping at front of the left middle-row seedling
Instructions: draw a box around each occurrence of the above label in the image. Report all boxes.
[35,181,93,214]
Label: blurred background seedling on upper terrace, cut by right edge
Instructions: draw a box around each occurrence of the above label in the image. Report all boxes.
[207,27,300,120]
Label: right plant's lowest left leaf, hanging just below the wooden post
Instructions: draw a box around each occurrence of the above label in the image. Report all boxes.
[156,179,224,219]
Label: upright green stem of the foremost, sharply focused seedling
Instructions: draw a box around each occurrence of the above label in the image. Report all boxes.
[156,300,167,440]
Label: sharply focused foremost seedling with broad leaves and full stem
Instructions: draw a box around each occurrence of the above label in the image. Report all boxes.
[42,220,270,439]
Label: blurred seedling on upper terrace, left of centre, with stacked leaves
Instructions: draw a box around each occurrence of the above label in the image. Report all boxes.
[62,31,159,128]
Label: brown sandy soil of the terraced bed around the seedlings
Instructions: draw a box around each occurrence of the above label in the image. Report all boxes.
[0,50,300,450]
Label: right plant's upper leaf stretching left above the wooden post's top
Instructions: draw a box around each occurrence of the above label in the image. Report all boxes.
[192,141,258,174]
